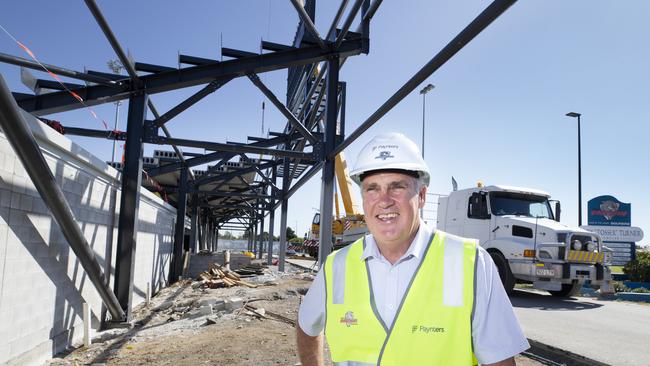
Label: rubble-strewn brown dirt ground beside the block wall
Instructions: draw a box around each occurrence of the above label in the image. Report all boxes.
[46,268,543,366]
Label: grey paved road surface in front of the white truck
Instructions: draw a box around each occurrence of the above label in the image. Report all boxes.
[510,290,650,365]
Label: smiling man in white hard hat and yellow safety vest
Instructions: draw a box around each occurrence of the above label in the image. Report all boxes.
[296,133,529,366]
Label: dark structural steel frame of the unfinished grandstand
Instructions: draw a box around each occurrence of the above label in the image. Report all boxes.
[0,0,516,321]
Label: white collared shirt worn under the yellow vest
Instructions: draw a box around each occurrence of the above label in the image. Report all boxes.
[298,221,530,363]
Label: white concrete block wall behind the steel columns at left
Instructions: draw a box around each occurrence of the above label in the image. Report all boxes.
[0,113,176,365]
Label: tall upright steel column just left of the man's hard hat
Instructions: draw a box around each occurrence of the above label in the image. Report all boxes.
[318,57,339,266]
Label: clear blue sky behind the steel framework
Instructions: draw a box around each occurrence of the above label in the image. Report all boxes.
[0,0,650,242]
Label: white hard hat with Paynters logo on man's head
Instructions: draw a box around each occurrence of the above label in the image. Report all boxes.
[350,132,429,186]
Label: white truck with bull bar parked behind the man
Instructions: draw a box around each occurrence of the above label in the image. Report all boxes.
[437,183,612,297]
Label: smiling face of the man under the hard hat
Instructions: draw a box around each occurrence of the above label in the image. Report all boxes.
[361,172,427,248]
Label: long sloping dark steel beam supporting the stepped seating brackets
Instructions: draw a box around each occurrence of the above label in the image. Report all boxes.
[18,39,362,116]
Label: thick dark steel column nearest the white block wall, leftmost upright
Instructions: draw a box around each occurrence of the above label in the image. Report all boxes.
[114,92,148,320]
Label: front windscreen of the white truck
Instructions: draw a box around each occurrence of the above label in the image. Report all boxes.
[490,192,553,219]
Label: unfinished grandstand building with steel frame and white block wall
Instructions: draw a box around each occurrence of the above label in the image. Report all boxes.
[0,0,514,364]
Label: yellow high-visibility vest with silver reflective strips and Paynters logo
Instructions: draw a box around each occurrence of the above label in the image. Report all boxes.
[324,231,477,365]
